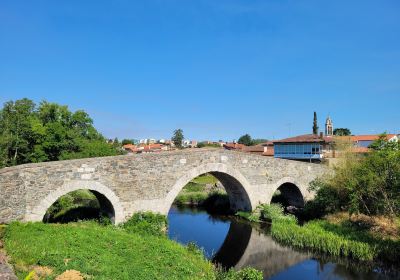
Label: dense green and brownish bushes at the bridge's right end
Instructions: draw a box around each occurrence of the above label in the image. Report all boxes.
[309,135,400,217]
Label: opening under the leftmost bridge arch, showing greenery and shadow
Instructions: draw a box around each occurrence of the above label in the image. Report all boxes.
[42,189,115,224]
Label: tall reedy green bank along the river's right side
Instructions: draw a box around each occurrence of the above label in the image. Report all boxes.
[238,205,400,262]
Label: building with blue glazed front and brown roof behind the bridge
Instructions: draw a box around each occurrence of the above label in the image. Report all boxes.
[273,133,333,160]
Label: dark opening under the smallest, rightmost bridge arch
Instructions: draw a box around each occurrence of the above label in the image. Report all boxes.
[271,182,304,209]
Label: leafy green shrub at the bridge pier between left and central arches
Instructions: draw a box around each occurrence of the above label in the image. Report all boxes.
[122,212,168,236]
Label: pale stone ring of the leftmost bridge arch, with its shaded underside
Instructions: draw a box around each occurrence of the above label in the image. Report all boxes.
[25,180,125,224]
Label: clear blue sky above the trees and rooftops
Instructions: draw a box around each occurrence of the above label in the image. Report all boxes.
[0,0,400,140]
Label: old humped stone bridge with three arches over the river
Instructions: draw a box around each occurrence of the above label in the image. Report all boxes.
[0,149,327,224]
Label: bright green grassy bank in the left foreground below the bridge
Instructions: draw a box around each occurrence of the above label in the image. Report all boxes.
[3,214,262,280]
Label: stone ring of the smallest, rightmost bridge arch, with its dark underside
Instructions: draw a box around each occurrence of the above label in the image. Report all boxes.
[268,177,310,207]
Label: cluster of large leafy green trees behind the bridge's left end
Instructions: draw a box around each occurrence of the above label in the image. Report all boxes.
[0,98,120,167]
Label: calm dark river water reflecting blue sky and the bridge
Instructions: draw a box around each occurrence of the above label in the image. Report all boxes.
[168,206,400,280]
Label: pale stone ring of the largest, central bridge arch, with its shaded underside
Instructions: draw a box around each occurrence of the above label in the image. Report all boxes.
[164,163,254,213]
